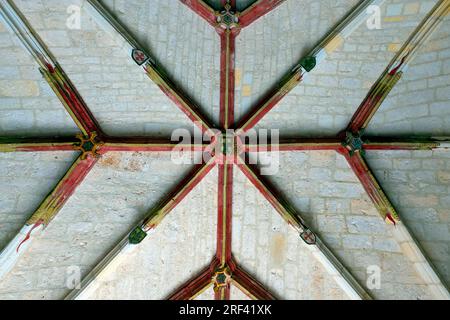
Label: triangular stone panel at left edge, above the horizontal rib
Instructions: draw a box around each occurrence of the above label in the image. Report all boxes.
[0,23,78,136]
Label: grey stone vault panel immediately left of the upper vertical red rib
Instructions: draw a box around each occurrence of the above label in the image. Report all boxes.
[102,0,220,123]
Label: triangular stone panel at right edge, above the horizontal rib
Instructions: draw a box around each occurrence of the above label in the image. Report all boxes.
[367,15,450,135]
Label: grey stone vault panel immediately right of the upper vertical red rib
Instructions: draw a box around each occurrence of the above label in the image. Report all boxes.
[236,0,358,125]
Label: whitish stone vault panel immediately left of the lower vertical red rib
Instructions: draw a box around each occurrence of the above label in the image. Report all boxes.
[86,165,217,299]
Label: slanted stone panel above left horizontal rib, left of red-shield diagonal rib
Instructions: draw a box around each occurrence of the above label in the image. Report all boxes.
[17,0,194,137]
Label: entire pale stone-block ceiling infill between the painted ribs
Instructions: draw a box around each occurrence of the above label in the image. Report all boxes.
[0,0,450,299]
